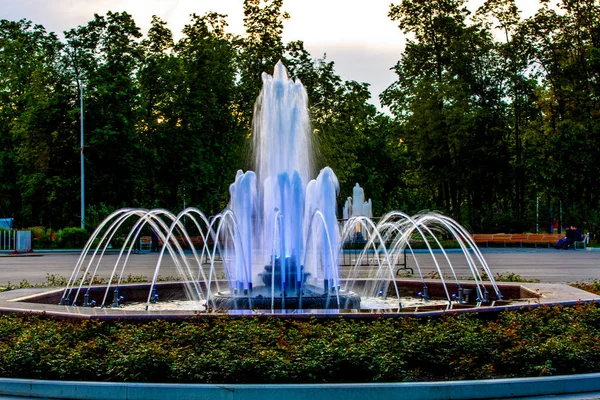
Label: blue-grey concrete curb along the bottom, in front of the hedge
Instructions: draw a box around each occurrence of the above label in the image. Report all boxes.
[0,373,600,400]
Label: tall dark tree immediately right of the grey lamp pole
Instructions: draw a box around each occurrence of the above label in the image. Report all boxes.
[65,12,145,216]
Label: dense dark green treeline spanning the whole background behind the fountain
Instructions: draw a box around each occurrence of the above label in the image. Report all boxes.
[0,0,600,232]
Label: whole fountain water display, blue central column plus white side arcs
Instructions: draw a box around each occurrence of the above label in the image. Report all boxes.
[60,62,502,311]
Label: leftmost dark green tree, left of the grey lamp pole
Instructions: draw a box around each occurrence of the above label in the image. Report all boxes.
[0,20,78,226]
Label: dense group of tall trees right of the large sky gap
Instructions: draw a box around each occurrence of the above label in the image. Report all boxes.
[382,0,600,231]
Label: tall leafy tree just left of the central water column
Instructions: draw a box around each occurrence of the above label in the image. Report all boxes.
[172,13,245,213]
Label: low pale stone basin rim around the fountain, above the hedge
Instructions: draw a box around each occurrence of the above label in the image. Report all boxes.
[0,279,564,320]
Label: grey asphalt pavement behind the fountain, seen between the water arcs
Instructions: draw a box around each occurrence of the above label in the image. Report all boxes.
[0,248,600,285]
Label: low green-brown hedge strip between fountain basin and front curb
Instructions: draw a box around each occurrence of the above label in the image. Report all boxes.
[0,305,600,383]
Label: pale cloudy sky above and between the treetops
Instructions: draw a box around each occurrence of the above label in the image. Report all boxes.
[0,0,538,107]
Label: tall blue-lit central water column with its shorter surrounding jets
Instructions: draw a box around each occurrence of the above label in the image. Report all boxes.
[224,62,340,302]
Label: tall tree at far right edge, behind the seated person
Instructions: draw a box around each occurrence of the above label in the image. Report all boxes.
[523,0,600,228]
